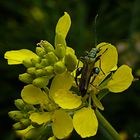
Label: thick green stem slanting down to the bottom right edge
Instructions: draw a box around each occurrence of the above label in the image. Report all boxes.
[95,109,121,140]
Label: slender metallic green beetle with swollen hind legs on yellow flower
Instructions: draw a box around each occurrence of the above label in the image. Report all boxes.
[75,44,107,96]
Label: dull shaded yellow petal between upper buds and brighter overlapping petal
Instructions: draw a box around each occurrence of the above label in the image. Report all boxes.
[50,72,74,96]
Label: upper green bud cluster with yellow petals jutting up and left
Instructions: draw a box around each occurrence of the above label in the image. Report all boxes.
[5,13,77,88]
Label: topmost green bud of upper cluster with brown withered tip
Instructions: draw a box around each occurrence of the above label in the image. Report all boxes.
[37,40,54,52]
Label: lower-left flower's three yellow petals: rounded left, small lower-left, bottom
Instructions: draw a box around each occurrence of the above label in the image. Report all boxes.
[21,85,73,139]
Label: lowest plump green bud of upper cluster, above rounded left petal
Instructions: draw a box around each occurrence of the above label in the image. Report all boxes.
[32,76,49,88]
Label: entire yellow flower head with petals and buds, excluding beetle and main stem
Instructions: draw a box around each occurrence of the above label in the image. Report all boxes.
[5,12,133,140]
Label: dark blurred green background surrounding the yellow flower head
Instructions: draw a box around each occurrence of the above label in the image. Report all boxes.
[0,0,140,140]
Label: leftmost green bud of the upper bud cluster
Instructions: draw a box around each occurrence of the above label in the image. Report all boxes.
[19,73,33,84]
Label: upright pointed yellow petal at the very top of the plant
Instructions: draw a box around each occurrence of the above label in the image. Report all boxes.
[55,12,71,38]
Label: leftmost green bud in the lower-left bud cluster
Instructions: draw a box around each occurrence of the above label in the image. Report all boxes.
[8,110,25,121]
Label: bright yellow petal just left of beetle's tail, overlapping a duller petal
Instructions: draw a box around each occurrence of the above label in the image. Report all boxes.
[53,89,82,109]
